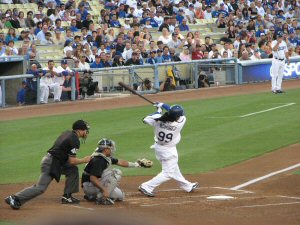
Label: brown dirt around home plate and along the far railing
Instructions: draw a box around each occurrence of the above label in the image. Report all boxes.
[0,80,300,225]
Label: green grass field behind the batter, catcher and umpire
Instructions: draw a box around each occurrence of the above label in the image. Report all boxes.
[0,89,300,184]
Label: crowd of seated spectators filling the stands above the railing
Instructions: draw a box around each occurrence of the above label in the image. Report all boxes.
[0,0,300,103]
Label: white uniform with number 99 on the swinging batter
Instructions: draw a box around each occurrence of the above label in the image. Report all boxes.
[141,109,193,193]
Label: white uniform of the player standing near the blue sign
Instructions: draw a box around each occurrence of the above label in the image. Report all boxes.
[271,40,288,92]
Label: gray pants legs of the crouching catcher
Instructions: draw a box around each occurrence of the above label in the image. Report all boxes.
[82,168,125,201]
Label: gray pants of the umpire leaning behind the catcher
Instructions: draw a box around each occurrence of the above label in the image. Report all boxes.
[15,154,79,204]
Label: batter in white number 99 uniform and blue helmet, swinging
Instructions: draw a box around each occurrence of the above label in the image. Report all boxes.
[139,103,198,197]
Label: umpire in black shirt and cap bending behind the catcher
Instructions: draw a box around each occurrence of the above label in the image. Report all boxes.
[5,120,90,209]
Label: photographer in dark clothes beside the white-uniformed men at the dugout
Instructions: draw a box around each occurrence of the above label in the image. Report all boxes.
[79,71,98,99]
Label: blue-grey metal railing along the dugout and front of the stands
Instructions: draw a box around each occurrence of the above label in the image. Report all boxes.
[0,58,239,107]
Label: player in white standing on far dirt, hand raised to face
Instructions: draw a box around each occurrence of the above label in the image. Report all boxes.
[271,32,290,94]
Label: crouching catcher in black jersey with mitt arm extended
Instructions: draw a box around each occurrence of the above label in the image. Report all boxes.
[82,138,153,205]
